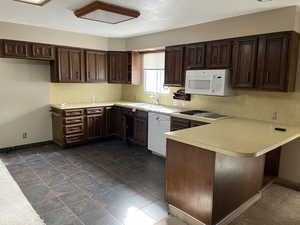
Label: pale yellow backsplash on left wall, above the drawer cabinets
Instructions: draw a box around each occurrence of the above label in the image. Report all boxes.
[49,83,122,104]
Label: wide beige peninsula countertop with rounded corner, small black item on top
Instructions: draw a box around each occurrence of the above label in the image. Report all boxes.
[166,118,300,157]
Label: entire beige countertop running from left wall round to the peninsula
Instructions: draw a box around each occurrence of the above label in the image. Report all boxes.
[51,101,300,157]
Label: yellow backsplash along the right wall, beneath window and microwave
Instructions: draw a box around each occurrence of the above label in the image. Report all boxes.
[122,85,300,125]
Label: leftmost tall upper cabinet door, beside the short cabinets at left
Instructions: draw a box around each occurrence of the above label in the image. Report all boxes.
[56,48,72,82]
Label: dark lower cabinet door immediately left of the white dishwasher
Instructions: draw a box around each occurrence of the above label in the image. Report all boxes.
[134,117,148,146]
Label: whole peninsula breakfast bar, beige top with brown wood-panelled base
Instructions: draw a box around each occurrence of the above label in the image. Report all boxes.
[166,118,300,225]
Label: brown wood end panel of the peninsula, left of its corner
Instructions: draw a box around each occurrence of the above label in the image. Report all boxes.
[166,140,215,224]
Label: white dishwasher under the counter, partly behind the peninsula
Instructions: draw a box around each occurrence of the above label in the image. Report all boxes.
[148,113,171,156]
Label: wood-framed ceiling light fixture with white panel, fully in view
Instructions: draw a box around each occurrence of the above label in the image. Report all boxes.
[74,1,140,24]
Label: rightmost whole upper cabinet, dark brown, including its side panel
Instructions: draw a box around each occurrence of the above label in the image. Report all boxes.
[257,32,299,91]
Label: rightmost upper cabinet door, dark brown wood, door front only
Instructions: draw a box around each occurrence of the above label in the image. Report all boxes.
[257,33,289,91]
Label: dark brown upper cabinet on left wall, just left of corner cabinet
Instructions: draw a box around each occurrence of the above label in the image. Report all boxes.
[85,50,107,83]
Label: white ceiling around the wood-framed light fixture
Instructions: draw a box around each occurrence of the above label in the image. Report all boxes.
[0,0,300,37]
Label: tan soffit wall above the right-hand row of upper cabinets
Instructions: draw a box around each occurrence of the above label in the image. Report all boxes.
[126,6,296,50]
